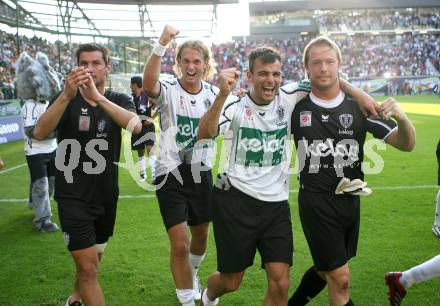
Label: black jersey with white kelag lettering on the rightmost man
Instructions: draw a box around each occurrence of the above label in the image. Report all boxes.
[292,92,396,193]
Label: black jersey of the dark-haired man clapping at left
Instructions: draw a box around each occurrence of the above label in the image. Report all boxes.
[49,90,135,203]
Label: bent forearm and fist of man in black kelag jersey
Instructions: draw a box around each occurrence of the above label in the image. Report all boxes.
[381,98,416,152]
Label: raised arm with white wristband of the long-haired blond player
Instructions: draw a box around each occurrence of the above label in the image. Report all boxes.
[142,25,179,97]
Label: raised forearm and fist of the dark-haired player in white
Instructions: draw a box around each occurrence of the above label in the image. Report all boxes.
[197,68,239,139]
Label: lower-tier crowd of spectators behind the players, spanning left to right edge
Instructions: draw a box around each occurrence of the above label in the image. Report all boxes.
[0,23,440,99]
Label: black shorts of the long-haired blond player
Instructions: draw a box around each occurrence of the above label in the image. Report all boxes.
[154,164,212,231]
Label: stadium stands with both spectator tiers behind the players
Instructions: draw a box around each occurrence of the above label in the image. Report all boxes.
[0,0,440,99]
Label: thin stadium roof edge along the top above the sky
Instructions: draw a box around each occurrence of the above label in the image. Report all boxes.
[76,0,238,5]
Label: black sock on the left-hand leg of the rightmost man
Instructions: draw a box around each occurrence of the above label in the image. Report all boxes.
[288,266,327,306]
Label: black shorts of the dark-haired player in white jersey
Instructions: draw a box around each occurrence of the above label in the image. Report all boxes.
[212,186,293,273]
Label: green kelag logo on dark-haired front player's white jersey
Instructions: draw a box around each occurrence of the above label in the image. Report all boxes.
[235,127,287,167]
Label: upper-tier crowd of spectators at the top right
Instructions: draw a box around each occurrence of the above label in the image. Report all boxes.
[315,9,440,32]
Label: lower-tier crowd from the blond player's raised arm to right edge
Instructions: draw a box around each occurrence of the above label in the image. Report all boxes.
[162,34,440,85]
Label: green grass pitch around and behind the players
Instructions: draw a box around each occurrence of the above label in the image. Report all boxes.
[0,96,440,306]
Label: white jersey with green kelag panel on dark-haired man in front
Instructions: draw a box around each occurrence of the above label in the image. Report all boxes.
[219,83,309,202]
